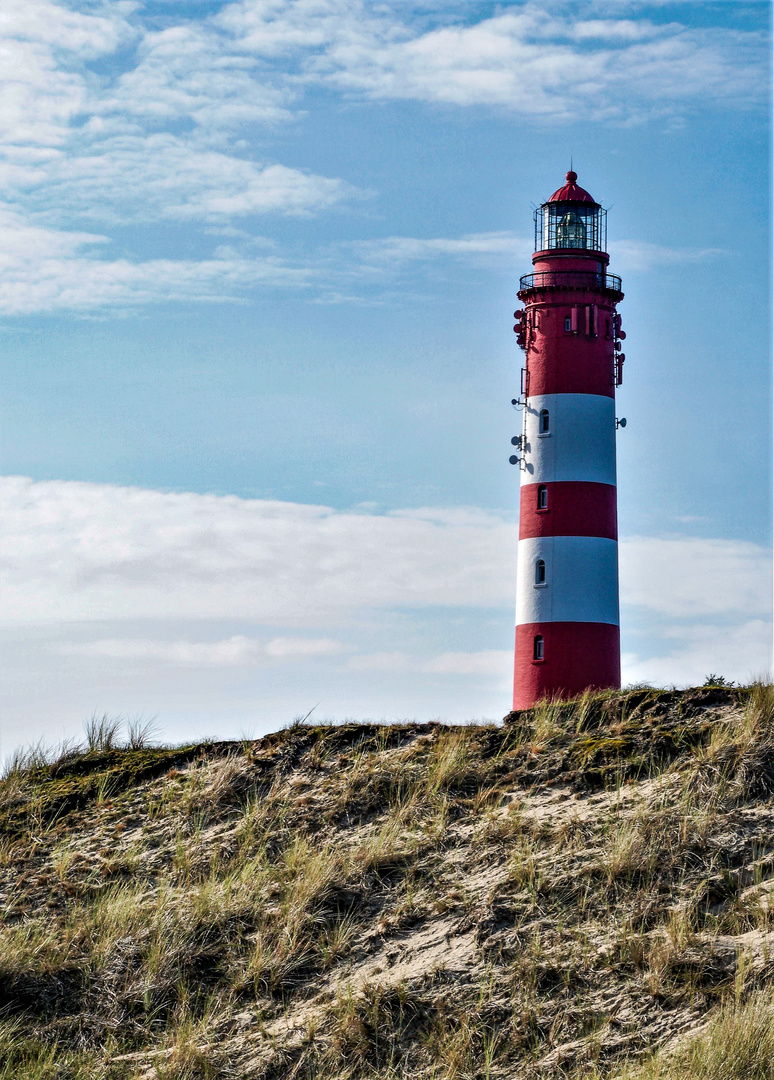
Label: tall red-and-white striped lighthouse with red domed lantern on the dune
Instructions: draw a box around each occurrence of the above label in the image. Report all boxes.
[511,171,626,710]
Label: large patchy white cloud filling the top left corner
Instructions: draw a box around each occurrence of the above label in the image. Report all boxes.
[0,0,355,267]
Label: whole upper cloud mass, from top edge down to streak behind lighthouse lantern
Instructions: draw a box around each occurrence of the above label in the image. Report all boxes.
[0,0,769,314]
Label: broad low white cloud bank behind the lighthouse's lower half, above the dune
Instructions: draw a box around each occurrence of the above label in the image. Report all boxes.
[0,477,772,741]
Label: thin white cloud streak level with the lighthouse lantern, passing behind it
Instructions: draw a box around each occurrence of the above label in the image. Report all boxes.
[0,217,721,315]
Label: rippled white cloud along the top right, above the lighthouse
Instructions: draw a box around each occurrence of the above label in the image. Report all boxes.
[282,0,766,121]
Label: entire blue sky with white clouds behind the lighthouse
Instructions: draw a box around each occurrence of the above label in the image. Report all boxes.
[0,0,772,756]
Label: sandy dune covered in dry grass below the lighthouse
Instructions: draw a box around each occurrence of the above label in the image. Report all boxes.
[0,684,774,1080]
